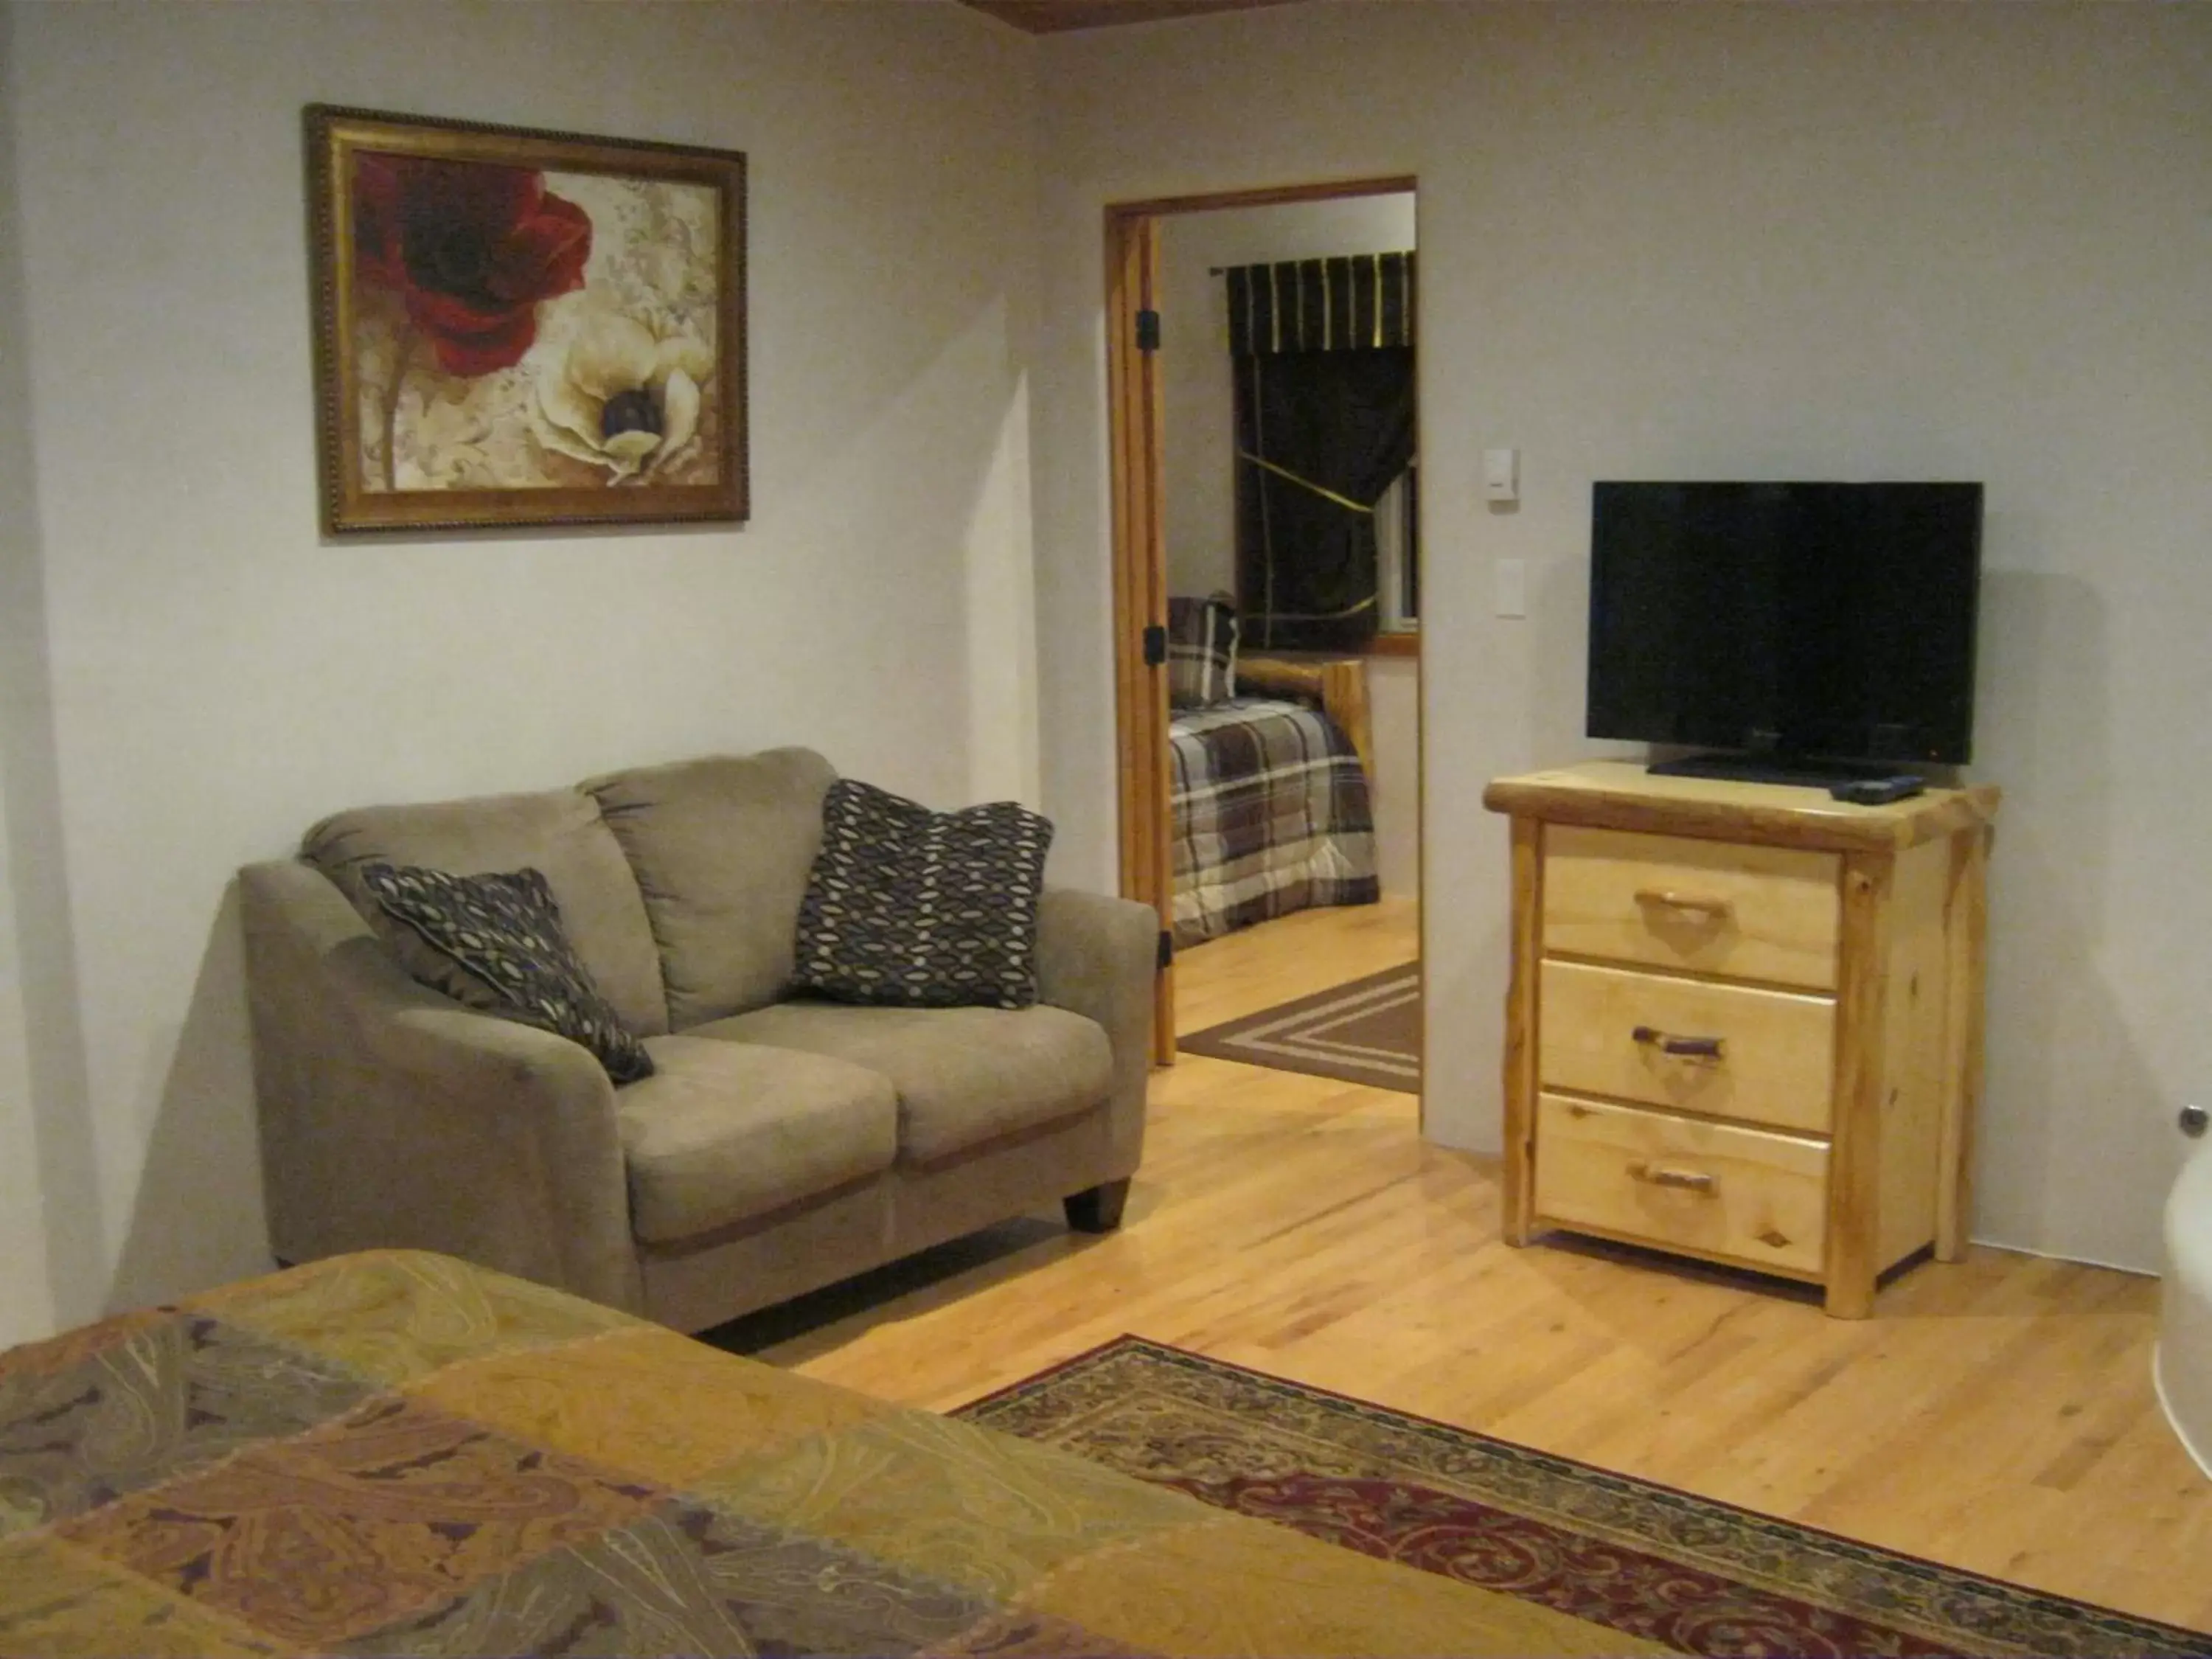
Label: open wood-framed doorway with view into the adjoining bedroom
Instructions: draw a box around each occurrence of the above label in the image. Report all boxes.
[1108,179,1420,1117]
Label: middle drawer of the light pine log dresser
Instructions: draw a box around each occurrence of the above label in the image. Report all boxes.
[1537,962,1836,1135]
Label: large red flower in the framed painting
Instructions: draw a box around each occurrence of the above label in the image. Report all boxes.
[354,150,591,374]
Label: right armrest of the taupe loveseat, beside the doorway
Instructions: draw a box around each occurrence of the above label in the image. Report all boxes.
[1037,887,1159,1179]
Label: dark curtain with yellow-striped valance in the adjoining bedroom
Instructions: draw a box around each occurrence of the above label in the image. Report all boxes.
[1228,254,1413,650]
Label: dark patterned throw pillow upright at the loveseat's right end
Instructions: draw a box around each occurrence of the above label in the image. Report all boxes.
[796,779,1053,1009]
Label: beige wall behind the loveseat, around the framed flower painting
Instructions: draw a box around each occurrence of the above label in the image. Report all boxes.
[0,0,1037,1325]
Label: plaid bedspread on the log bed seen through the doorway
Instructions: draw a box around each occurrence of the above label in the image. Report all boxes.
[1170,697,1382,947]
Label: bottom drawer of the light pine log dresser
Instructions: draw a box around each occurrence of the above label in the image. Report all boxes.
[1535,1095,1827,1276]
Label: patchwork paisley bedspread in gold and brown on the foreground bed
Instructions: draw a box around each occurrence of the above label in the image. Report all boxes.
[0,1252,1637,1659]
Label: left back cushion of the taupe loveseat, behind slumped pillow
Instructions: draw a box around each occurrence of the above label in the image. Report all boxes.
[301,790,668,1035]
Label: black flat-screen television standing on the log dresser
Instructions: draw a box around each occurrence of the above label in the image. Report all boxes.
[1588,482,1982,776]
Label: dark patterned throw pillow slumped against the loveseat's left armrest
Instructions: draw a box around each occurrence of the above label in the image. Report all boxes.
[361,863,653,1084]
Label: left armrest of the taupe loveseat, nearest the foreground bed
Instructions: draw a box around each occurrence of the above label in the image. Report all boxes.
[239,860,644,1312]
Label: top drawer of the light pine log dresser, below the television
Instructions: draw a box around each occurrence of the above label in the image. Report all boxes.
[1544,825,1843,991]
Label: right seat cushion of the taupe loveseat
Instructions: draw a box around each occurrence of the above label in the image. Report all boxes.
[692,998,1113,1164]
